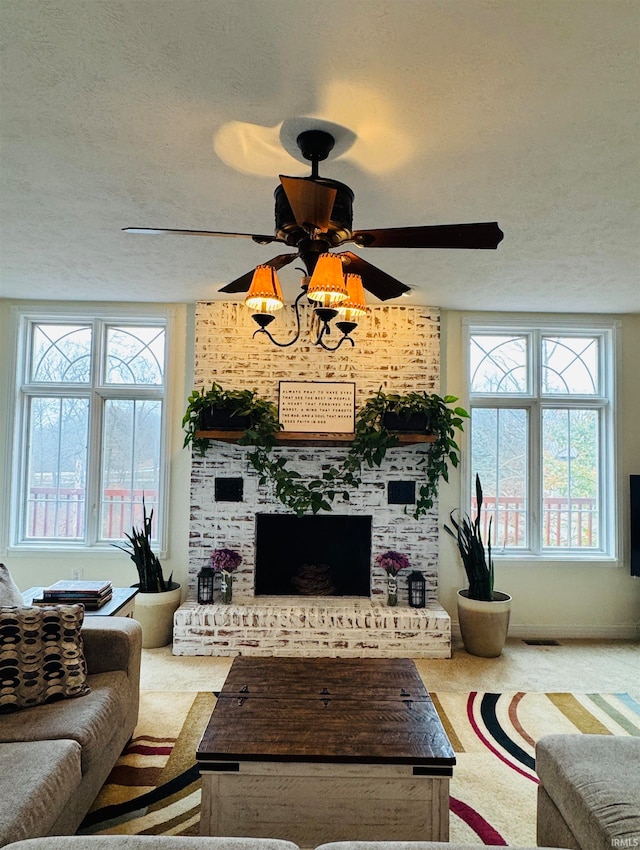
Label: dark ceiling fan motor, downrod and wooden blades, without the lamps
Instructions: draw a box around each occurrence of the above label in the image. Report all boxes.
[123,124,504,301]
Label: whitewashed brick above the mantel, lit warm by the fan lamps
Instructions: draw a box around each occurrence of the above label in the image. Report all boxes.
[195,302,440,404]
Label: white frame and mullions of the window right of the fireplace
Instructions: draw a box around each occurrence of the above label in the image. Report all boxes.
[461,314,621,563]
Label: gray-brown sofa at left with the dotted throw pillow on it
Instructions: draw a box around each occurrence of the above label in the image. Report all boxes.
[0,617,142,847]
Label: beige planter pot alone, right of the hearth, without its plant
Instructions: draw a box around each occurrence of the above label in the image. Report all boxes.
[458,590,511,658]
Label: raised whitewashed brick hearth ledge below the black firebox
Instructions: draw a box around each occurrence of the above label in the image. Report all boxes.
[173,596,451,658]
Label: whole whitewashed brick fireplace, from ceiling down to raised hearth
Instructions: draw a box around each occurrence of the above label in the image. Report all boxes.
[173,302,450,657]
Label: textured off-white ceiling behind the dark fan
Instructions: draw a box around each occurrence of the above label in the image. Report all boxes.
[0,0,640,312]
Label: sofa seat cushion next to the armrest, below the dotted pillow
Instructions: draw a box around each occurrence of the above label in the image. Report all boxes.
[0,671,129,774]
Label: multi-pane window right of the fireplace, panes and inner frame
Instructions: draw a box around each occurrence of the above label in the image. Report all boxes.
[467,323,615,558]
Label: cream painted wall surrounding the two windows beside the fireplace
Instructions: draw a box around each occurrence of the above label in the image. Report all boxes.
[0,300,640,637]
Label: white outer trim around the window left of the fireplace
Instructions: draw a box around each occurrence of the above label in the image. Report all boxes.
[5,302,175,558]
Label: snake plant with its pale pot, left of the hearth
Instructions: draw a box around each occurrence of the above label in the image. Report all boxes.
[113,498,181,649]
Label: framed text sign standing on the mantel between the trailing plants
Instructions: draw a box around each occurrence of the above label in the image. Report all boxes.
[279,381,356,434]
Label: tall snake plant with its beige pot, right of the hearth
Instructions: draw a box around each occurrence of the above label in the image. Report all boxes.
[444,475,511,658]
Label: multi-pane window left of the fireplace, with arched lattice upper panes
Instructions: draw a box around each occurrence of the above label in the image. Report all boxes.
[11,316,166,547]
